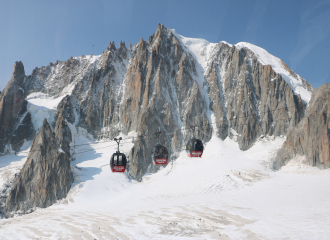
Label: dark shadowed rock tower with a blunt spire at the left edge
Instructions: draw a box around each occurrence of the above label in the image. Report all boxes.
[0,62,34,152]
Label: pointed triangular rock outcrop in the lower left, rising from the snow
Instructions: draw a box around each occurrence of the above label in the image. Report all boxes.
[5,119,73,217]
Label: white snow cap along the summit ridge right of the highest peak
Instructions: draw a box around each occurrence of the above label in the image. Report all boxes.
[171,29,312,103]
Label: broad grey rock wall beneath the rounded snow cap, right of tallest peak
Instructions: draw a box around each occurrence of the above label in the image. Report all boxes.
[206,42,311,150]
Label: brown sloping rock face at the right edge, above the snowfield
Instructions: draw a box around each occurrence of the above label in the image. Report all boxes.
[274,84,330,169]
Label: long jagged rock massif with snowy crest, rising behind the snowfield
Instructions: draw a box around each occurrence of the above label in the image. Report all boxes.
[0,24,313,182]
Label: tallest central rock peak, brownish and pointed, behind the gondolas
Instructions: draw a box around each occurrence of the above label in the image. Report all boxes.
[120,24,211,179]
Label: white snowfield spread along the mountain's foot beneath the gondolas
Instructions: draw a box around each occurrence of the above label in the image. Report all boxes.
[0,134,330,239]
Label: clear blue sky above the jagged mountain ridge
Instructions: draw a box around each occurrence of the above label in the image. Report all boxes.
[0,0,330,90]
